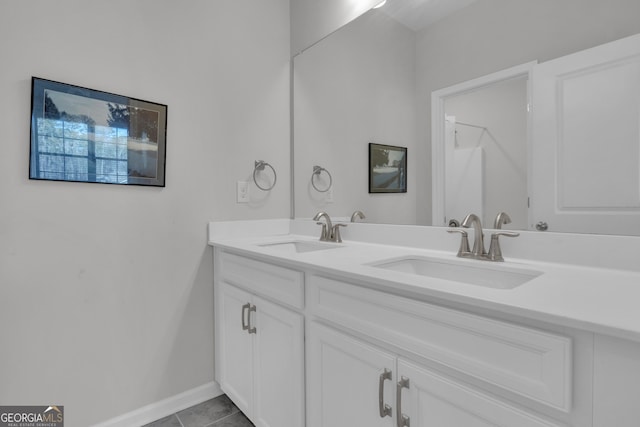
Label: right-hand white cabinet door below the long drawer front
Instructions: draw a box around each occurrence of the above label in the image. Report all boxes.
[396,359,561,427]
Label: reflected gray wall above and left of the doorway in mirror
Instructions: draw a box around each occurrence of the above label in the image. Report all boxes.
[416,0,640,224]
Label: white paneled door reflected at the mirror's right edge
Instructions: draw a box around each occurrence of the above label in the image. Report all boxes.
[531,35,640,235]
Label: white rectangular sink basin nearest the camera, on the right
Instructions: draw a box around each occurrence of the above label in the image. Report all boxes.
[372,257,542,289]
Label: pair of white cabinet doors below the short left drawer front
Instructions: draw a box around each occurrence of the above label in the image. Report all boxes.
[215,281,304,427]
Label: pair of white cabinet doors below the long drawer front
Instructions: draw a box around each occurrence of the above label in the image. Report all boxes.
[306,322,562,427]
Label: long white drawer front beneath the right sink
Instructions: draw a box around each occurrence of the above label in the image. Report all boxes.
[307,276,572,412]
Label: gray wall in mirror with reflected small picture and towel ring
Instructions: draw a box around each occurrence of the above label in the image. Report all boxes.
[294,10,417,224]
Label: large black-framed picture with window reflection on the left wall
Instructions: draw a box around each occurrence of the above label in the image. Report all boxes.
[29,77,167,187]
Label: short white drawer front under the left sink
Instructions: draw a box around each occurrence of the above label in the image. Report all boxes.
[216,252,304,309]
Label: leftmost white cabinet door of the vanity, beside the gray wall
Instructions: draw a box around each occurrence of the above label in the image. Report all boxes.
[215,282,253,414]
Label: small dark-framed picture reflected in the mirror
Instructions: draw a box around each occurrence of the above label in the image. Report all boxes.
[369,142,407,193]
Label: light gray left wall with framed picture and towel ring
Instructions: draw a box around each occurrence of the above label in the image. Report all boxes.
[0,0,290,427]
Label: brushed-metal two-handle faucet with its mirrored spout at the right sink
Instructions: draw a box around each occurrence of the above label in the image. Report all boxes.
[447,212,520,261]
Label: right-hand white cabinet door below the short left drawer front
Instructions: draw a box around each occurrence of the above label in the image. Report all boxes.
[251,297,304,427]
